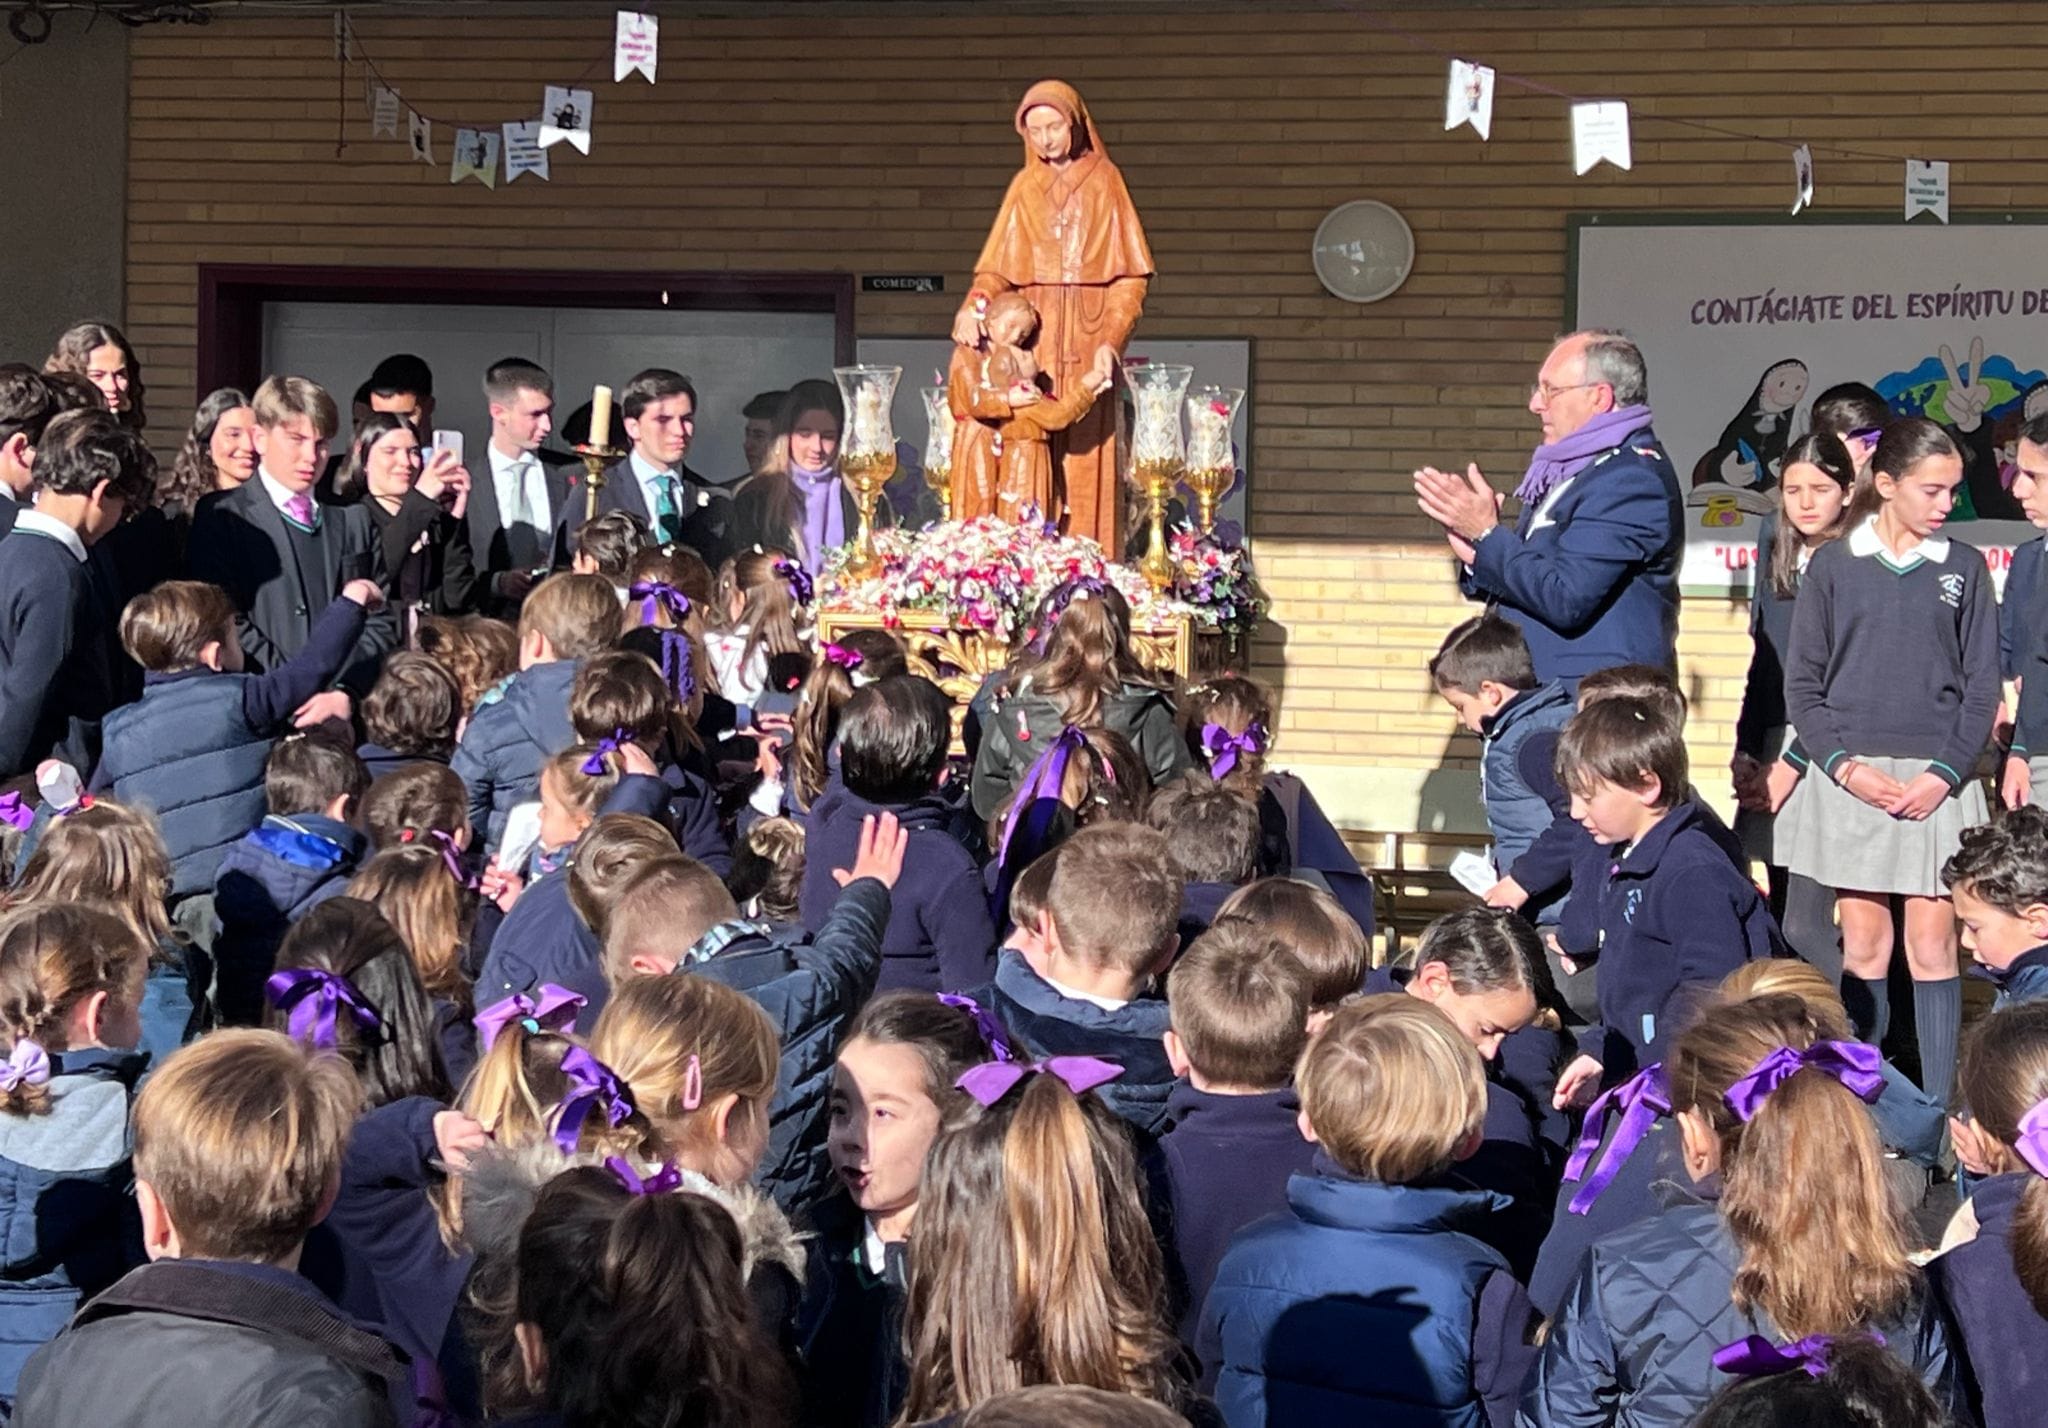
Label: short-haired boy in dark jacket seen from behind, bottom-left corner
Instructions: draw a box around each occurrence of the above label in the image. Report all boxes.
[14,1031,408,1428]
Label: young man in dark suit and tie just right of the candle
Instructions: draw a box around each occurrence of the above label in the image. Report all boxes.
[563,367,731,570]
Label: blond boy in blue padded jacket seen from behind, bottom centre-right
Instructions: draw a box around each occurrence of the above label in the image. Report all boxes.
[1196,996,1534,1428]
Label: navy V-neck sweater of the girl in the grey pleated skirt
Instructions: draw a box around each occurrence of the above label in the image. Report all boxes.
[1786,516,1999,789]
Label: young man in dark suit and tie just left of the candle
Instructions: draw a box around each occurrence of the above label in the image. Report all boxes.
[469,356,584,615]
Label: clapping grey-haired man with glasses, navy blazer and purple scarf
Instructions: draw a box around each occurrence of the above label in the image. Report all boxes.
[1415,330,1686,688]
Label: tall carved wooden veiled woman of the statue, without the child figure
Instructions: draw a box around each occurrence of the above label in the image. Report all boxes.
[952,80,1153,544]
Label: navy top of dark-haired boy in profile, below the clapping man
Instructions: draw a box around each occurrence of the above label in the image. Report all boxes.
[1579,801,1786,1080]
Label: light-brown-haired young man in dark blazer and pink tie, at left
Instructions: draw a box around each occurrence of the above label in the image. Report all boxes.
[188,377,397,723]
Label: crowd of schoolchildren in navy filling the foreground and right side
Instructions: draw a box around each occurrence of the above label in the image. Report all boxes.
[0,323,2048,1428]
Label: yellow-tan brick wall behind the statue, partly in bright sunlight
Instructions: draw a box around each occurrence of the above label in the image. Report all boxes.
[127,2,2048,830]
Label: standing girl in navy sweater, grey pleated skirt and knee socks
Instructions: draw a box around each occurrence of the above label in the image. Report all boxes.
[1786,418,1999,1098]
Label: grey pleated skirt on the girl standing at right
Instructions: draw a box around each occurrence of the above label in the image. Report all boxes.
[1774,756,1991,897]
